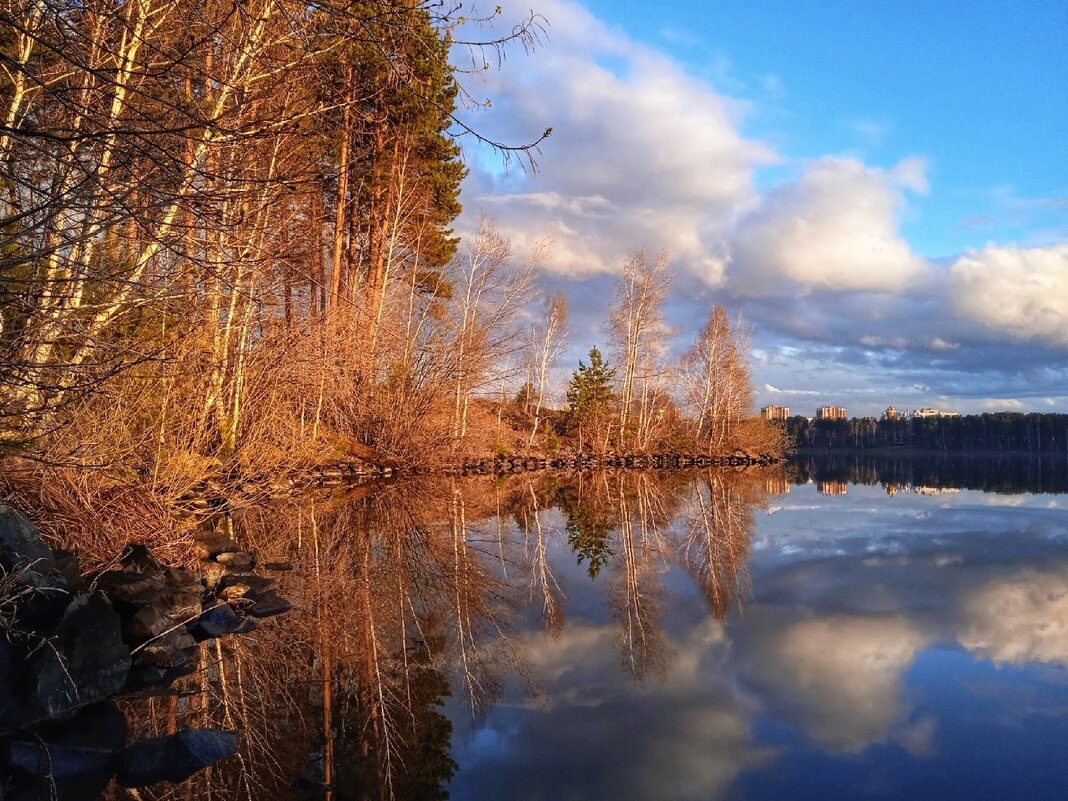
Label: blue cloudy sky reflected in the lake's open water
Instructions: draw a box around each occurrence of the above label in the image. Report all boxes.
[446,463,1068,801]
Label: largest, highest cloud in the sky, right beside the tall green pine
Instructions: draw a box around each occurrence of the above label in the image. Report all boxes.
[454,0,776,284]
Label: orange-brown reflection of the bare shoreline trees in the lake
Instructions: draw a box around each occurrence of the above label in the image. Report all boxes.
[108,471,766,801]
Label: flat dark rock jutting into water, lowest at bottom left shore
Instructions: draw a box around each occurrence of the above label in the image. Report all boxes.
[116,728,237,787]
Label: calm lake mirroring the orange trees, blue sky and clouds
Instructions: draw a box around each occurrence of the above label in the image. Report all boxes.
[124,456,1068,801]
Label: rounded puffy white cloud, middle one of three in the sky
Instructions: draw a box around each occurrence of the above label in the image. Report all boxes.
[727,157,926,297]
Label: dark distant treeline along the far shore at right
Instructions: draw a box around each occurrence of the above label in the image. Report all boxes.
[785,412,1068,453]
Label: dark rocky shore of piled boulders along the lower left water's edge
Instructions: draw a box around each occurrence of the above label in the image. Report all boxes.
[0,503,290,801]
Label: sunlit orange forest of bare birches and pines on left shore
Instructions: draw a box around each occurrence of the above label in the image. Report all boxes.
[0,0,779,521]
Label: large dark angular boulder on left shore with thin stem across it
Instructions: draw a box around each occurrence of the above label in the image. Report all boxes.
[21,593,130,719]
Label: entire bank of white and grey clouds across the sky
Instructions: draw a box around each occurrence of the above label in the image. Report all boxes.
[456,0,1068,413]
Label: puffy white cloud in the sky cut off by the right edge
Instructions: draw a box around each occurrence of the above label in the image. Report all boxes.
[949,242,1068,347]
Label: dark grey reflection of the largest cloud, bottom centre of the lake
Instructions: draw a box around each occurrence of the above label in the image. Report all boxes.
[452,619,772,801]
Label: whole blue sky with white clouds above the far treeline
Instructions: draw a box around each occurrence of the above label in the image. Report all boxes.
[456,0,1068,417]
